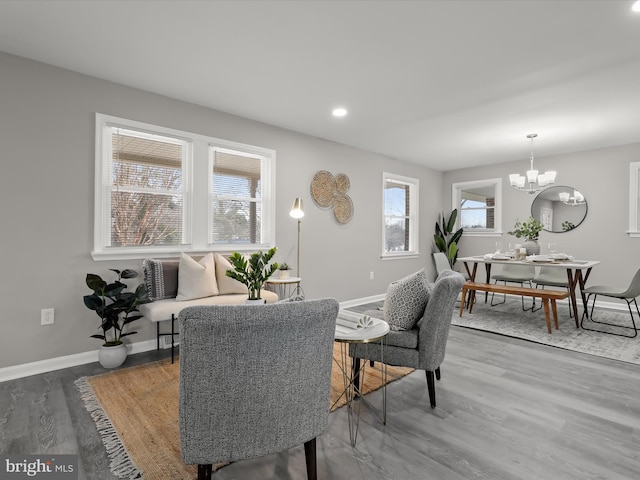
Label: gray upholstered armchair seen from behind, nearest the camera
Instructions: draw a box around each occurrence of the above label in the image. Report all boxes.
[178,299,338,480]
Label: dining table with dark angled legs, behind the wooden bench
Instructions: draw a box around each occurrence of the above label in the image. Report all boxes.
[458,254,600,328]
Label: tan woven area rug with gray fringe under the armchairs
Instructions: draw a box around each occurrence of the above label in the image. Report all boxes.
[76,344,413,480]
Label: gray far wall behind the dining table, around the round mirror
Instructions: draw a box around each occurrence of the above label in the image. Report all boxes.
[442,144,640,286]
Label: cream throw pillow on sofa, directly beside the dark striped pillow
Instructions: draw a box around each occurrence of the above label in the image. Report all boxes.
[176,253,219,301]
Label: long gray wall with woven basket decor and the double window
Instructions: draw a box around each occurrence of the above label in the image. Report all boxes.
[0,53,443,368]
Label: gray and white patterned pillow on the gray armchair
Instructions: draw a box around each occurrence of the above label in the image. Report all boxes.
[383,268,431,330]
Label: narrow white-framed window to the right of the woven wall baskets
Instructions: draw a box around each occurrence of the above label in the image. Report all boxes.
[382,173,419,258]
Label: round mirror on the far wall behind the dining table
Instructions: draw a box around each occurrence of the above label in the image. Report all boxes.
[531,186,587,233]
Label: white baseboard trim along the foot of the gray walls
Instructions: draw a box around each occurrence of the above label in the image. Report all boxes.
[0,294,627,382]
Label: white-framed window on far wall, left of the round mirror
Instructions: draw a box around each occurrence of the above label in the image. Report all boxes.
[452,178,502,235]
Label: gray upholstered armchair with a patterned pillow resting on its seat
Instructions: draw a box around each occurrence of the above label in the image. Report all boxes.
[350,270,465,408]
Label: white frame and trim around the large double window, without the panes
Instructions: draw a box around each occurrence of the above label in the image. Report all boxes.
[91,113,276,260]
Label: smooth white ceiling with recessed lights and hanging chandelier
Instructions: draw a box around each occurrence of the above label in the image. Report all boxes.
[0,0,640,170]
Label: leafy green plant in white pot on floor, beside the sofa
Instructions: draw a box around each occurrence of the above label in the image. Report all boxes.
[84,269,149,368]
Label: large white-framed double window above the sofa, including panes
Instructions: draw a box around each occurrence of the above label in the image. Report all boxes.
[92,114,275,260]
